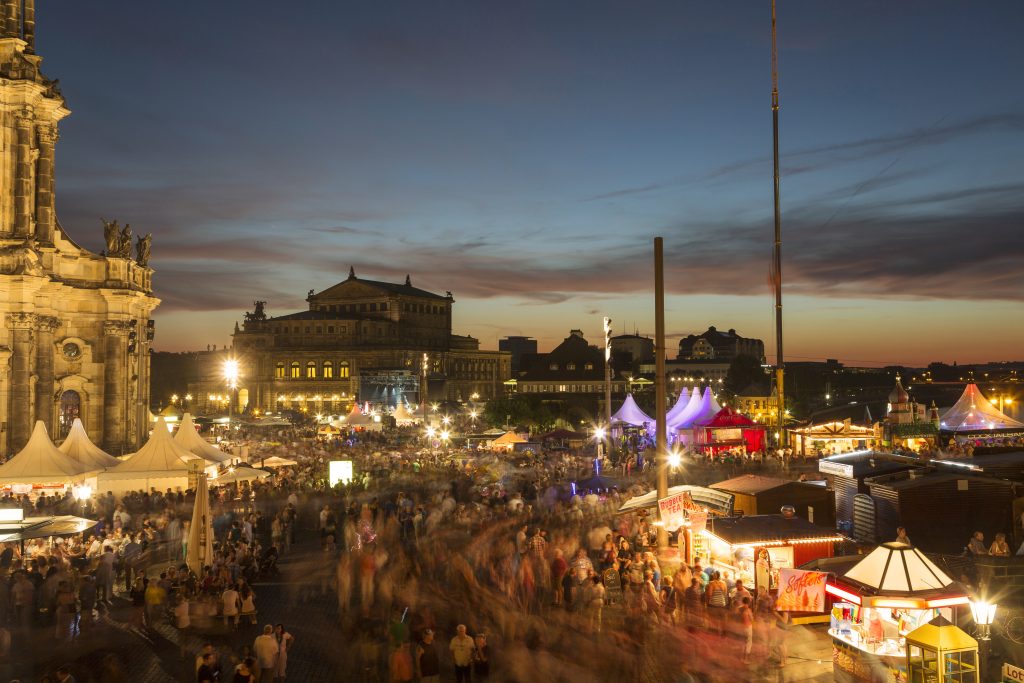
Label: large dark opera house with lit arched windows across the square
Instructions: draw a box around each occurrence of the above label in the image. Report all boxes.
[189,269,512,415]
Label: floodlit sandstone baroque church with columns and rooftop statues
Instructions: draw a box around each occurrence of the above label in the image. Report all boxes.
[0,0,160,457]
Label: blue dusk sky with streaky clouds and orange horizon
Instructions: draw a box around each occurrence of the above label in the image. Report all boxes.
[37,0,1024,365]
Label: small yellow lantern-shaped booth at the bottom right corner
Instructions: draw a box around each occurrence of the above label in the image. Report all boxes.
[906,616,979,683]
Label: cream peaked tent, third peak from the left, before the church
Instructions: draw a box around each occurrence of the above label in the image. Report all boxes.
[96,418,208,493]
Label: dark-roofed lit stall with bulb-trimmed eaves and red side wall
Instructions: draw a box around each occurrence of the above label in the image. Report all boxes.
[700,507,847,590]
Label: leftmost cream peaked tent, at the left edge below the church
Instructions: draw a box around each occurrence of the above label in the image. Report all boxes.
[0,420,101,495]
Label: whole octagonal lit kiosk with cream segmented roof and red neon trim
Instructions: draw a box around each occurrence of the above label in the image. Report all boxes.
[825,542,978,683]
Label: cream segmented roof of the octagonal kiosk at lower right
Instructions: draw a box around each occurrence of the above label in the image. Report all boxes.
[843,542,953,596]
